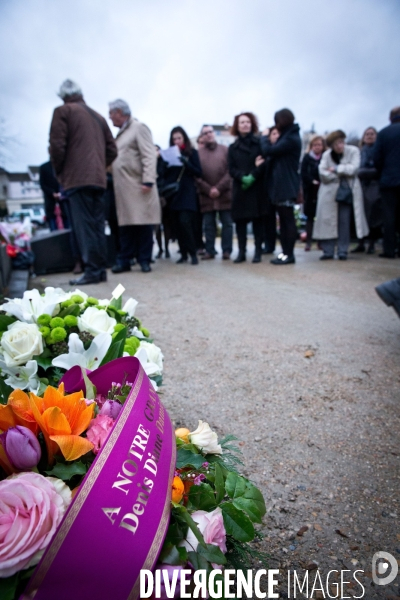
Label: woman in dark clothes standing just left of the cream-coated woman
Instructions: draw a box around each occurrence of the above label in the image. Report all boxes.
[300,135,326,251]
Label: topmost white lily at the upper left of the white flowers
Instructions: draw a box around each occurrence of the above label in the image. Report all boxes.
[0,287,67,323]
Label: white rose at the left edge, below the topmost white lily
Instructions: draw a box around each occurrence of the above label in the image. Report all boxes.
[0,321,43,367]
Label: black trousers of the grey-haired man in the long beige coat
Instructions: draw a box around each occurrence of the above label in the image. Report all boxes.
[117,225,153,268]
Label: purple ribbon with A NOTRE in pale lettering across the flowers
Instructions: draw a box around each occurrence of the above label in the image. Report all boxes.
[21,357,175,600]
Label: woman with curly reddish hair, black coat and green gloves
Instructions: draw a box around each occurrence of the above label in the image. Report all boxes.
[228,112,267,263]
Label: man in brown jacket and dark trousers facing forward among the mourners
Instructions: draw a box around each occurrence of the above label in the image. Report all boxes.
[196,125,233,260]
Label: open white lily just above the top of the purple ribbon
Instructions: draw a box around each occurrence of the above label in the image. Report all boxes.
[51,333,112,371]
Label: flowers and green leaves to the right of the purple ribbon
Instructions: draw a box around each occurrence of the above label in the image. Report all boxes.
[152,421,266,598]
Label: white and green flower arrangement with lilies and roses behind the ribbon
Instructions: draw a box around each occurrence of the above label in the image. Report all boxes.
[0,286,163,402]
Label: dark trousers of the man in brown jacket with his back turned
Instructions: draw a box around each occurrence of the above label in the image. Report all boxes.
[69,187,107,278]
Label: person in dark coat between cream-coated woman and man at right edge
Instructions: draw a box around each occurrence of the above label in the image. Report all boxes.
[351,127,382,254]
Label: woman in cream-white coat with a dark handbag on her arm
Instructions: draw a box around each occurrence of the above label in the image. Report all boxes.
[313,130,369,260]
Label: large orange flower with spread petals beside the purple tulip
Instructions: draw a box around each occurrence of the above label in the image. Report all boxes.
[21,384,94,465]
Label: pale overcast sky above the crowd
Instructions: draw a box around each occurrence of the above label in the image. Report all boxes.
[0,0,400,170]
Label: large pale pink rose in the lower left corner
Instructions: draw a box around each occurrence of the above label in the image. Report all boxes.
[0,473,71,577]
